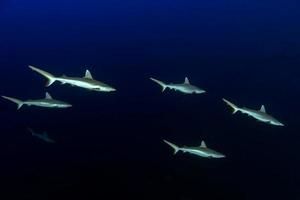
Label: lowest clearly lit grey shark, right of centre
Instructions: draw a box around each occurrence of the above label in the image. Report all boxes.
[163,140,225,158]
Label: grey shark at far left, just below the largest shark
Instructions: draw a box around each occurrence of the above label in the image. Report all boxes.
[2,92,72,110]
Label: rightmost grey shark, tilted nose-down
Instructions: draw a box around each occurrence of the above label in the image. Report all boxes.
[223,98,284,126]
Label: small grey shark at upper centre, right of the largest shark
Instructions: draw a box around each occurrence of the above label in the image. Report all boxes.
[150,77,206,94]
